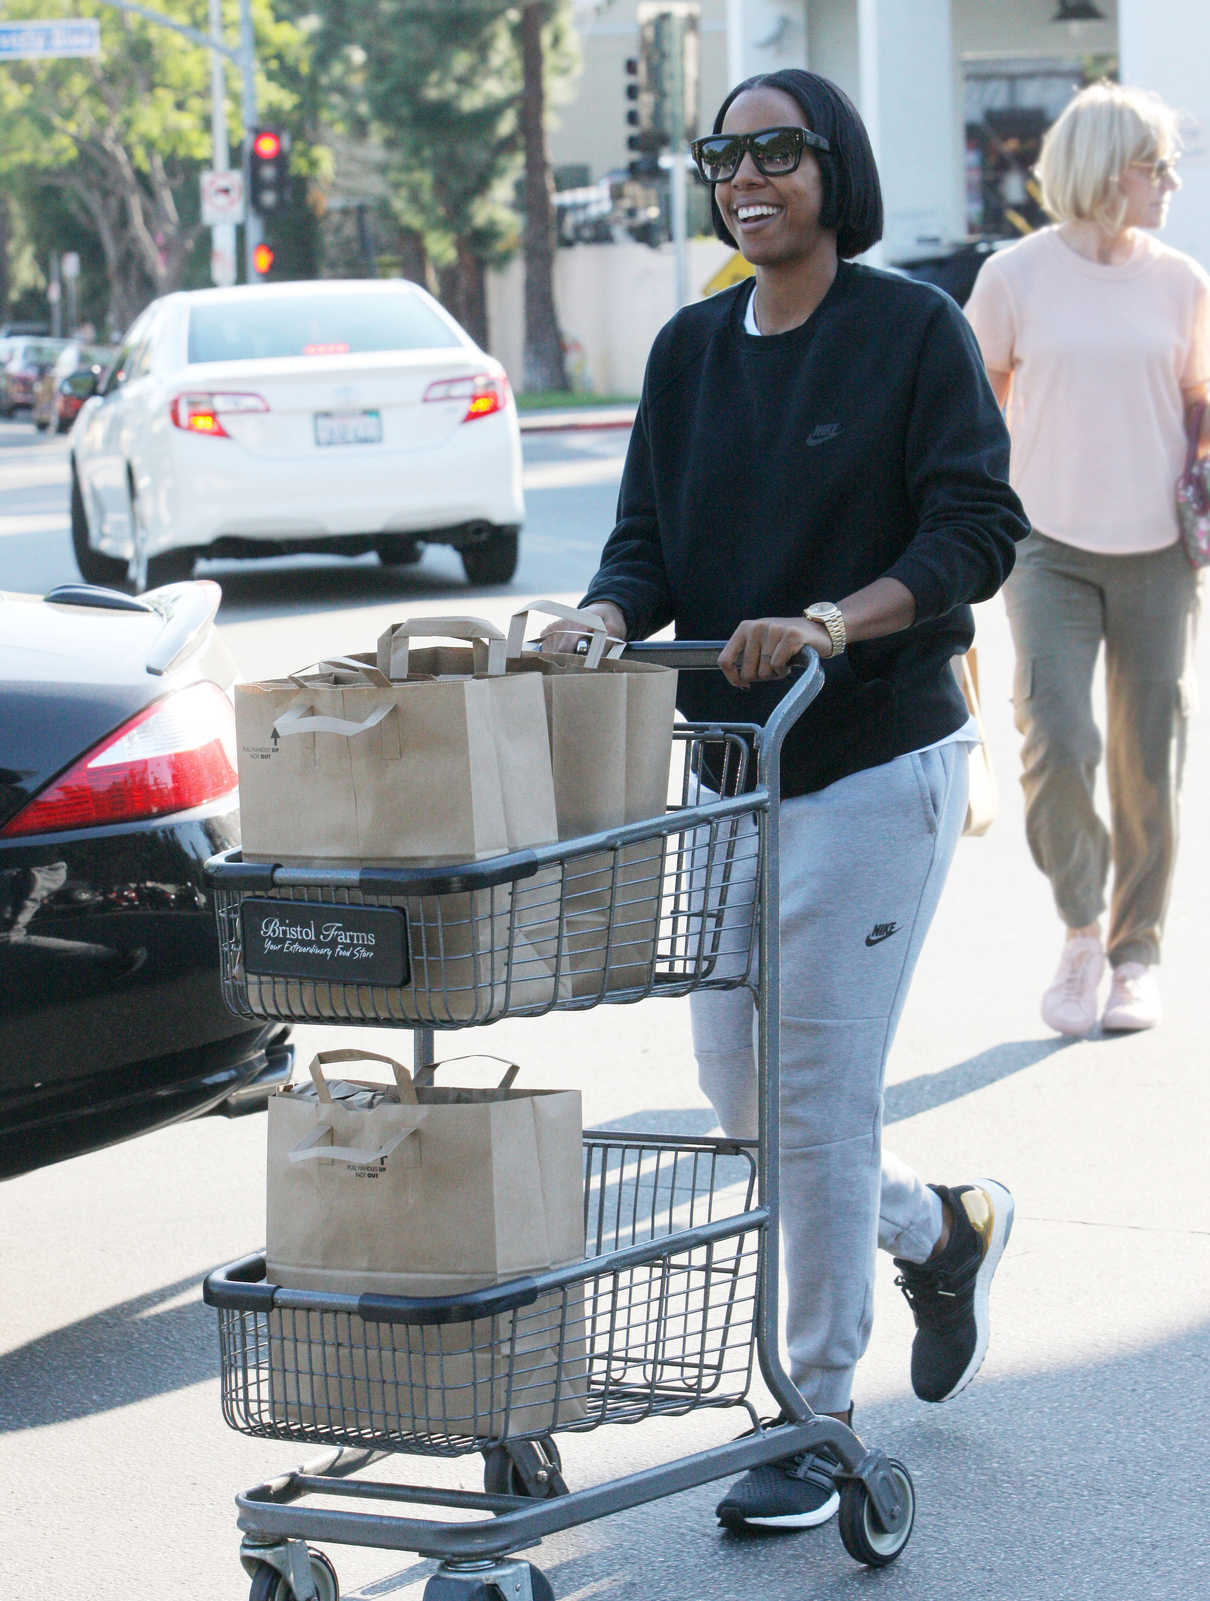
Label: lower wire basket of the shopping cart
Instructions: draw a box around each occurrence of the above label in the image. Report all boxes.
[205,1134,755,1455]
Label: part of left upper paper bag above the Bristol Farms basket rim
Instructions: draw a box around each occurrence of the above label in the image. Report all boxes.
[235,618,557,866]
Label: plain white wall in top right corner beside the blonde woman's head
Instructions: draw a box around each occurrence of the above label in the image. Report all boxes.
[1117,0,1210,267]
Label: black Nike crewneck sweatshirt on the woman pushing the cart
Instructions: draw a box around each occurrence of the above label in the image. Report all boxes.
[584,261,1029,796]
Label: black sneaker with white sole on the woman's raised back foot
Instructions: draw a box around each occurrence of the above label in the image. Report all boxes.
[895,1178,1013,1401]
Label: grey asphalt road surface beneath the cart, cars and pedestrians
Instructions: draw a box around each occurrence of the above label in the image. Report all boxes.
[0,424,1210,1601]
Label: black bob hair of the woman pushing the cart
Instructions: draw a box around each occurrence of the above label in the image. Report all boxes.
[711,67,882,259]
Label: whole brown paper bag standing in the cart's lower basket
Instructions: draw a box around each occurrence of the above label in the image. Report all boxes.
[266,1049,586,1438]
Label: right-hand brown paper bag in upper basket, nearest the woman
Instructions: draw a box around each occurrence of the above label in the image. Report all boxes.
[507,600,677,997]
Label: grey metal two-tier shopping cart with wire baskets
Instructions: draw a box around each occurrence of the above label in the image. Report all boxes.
[203,642,916,1601]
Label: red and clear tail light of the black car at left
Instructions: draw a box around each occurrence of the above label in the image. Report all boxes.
[0,684,238,837]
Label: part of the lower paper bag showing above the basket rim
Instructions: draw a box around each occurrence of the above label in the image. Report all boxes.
[267,1049,584,1295]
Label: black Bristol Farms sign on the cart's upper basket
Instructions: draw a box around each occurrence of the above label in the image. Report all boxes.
[240,898,408,985]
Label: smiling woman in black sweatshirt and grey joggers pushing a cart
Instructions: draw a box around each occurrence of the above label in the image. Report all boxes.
[547,70,1029,1526]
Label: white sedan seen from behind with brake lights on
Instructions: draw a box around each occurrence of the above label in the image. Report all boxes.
[70,279,525,591]
